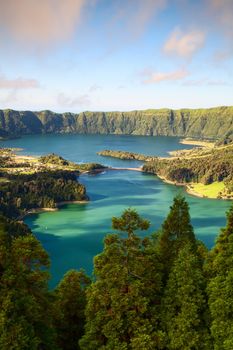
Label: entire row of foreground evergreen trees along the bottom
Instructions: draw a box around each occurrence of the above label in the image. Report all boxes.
[0,196,233,350]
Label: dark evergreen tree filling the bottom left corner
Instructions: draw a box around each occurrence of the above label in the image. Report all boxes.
[0,229,56,350]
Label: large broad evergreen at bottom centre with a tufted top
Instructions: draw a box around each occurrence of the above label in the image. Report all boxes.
[80,209,161,350]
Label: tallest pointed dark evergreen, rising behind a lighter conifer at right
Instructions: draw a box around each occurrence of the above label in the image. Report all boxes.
[158,195,196,283]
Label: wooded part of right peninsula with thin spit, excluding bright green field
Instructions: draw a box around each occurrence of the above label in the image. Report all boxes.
[98,144,233,186]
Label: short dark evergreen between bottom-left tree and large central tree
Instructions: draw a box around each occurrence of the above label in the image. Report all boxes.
[55,270,90,350]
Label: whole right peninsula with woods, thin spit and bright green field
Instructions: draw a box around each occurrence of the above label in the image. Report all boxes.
[98,140,233,199]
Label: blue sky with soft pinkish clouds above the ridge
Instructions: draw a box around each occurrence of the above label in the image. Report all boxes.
[0,0,233,112]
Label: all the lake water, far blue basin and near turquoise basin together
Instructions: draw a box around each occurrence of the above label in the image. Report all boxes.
[1,135,231,287]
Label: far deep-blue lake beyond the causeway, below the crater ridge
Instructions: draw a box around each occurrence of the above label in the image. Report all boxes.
[0,134,192,167]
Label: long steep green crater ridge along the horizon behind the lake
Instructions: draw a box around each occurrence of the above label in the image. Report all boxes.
[0,107,233,139]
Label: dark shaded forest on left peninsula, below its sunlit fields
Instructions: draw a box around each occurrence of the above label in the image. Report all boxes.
[0,171,86,217]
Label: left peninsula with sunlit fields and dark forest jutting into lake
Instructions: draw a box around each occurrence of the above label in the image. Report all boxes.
[0,149,104,219]
